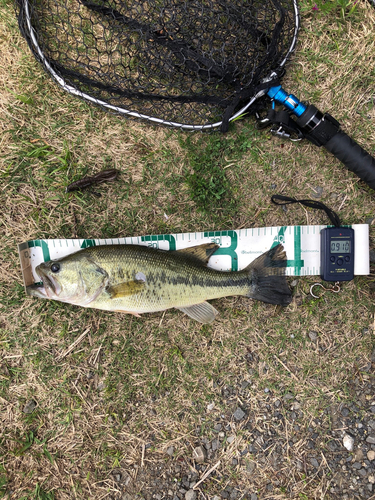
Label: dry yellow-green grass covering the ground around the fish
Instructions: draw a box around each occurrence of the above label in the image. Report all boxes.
[0,0,375,500]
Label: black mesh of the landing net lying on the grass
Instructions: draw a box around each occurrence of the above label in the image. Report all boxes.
[17,0,296,126]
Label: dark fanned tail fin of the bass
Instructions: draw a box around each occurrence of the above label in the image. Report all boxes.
[246,245,292,306]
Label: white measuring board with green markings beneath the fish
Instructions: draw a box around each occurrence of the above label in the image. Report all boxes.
[18,224,370,292]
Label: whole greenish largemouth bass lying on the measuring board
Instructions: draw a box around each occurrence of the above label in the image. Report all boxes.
[27,243,291,323]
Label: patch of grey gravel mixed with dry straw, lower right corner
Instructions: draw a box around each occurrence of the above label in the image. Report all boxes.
[105,379,375,500]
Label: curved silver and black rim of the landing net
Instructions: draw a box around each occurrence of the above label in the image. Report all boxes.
[18,0,300,131]
